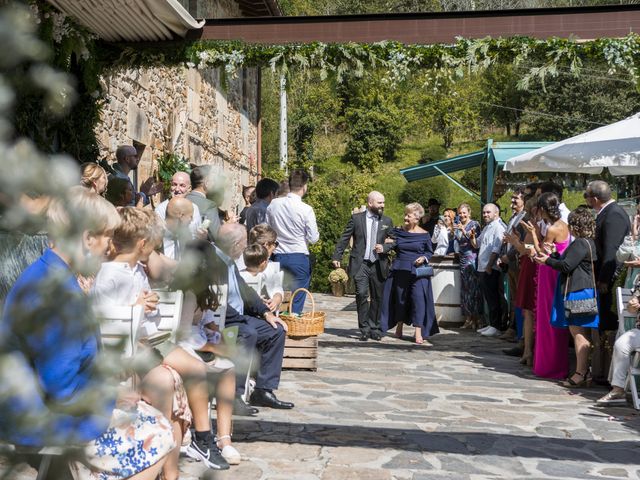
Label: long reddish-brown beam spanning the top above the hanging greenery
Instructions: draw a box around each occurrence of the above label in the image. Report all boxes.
[188,5,640,44]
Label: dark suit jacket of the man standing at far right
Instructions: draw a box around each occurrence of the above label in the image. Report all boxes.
[595,202,631,286]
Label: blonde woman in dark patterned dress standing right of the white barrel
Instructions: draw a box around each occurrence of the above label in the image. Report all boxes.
[453,203,483,328]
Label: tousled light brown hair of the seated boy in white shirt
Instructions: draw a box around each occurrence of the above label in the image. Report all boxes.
[112,207,164,253]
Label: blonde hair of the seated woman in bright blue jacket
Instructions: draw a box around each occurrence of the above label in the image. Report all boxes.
[47,185,120,241]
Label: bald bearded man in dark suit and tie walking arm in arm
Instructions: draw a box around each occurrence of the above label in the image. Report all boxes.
[333,192,393,342]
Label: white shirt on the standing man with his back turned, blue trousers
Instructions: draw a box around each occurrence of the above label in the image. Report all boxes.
[267,193,320,255]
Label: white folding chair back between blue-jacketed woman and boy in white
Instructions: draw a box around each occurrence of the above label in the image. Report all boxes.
[96,305,144,357]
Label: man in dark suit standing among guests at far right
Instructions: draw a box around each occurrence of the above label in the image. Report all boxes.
[584,180,631,331]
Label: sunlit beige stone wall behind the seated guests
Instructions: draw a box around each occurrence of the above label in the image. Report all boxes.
[97,64,258,212]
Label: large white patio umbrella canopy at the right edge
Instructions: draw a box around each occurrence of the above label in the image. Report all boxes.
[504,113,640,175]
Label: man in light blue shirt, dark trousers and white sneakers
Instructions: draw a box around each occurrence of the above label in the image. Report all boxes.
[471,203,507,337]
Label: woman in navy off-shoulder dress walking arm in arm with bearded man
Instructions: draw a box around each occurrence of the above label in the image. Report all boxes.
[380,203,439,344]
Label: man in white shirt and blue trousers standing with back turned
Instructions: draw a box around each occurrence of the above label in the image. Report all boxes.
[267,170,320,313]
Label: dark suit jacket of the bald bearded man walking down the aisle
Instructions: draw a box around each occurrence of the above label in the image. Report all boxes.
[333,211,393,278]
